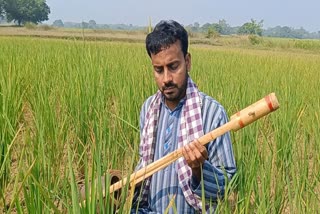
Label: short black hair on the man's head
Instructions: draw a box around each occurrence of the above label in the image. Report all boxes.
[146,20,188,57]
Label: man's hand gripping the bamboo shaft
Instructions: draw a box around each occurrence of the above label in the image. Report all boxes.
[182,140,208,181]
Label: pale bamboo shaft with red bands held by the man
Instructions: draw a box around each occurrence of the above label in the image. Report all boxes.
[81,93,279,206]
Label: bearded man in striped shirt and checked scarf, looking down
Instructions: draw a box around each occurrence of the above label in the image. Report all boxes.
[131,21,236,213]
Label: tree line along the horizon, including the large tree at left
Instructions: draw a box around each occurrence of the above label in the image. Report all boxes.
[0,0,320,39]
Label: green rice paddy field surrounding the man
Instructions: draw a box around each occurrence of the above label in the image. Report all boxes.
[0,36,320,213]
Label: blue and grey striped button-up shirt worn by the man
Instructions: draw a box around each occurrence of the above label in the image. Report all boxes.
[132,93,236,213]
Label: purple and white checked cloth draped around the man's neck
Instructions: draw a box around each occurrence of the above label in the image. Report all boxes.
[140,77,203,210]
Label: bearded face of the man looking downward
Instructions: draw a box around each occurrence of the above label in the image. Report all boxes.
[151,41,191,109]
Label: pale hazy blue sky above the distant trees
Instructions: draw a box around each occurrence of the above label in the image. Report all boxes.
[46,0,320,32]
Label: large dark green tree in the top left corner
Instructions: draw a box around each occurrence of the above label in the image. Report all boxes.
[2,0,50,25]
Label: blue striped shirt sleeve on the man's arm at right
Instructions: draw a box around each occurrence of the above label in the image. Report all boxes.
[190,103,236,201]
